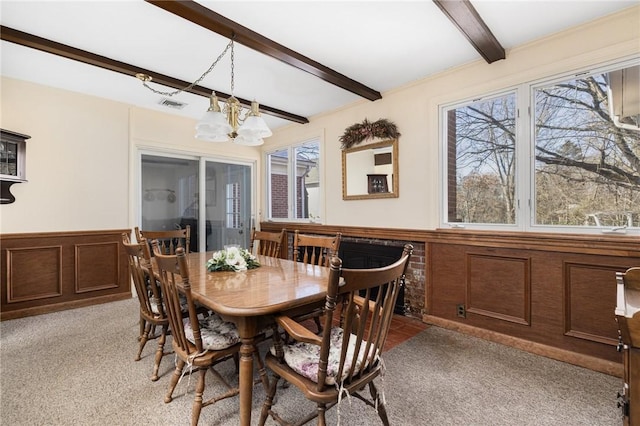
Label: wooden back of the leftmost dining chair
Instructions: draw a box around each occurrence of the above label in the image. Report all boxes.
[122,233,164,319]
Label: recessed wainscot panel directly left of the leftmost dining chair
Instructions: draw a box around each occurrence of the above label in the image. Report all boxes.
[75,241,120,293]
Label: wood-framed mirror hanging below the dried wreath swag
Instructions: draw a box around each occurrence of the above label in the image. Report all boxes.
[342,139,398,200]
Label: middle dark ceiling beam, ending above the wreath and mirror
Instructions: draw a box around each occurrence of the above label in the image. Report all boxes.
[145,0,382,101]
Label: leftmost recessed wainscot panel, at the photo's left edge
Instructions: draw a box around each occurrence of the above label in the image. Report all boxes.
[5,246,62,304]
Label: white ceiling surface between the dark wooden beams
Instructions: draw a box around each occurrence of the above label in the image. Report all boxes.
[0,0,639,128]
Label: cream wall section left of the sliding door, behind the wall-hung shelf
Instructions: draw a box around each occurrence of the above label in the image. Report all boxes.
[0,78,129,233]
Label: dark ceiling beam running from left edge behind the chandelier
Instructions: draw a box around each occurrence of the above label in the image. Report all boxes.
[0,25,309,124]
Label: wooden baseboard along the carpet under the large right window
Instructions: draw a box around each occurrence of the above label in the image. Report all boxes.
[422,315,624,378]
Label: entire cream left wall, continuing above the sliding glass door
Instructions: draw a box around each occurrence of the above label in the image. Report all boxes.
[0,78,260,233]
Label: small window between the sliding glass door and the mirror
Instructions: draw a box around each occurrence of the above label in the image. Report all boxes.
[266,139,322,220]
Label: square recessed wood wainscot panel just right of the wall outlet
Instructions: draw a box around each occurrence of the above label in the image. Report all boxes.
[466,253,531,325]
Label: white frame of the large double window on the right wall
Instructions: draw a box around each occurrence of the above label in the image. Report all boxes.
[438,57,640,235]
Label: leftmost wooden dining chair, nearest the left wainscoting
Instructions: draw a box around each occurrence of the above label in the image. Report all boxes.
[122,233,170,381]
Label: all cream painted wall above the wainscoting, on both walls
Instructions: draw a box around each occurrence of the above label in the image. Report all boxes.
[0,6,640,233]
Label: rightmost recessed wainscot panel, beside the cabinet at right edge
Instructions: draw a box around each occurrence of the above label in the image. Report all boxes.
[564,262,620,346]
